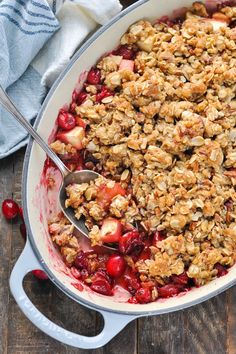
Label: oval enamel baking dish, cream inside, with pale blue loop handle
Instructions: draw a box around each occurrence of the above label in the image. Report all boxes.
[10,0,236,348]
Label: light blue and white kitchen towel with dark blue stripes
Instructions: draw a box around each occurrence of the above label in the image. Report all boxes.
[0,0,121,158]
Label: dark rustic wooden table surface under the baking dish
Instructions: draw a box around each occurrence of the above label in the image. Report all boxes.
[0,0,236,354]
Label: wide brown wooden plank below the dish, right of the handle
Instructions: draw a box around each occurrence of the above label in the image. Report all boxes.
[138,294,227,354]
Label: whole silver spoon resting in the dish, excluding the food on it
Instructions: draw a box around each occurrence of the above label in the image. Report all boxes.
[0,86,115,250]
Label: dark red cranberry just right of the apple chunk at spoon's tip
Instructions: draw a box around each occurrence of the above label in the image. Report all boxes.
[119,231,144,254]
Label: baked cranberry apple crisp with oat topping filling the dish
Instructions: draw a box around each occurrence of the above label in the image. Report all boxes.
[49,2,236,303]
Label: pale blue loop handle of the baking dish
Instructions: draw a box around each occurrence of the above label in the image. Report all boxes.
[10,241,137,349]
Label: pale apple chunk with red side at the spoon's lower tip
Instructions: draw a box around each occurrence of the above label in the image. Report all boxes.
[101,218,122,243]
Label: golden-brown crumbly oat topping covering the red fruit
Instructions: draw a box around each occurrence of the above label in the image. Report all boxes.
[48,2,236,302]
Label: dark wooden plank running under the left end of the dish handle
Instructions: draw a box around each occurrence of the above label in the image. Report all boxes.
[5,151,59,354]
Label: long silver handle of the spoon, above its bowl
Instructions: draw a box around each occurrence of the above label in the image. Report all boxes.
[0,86,70,176]
